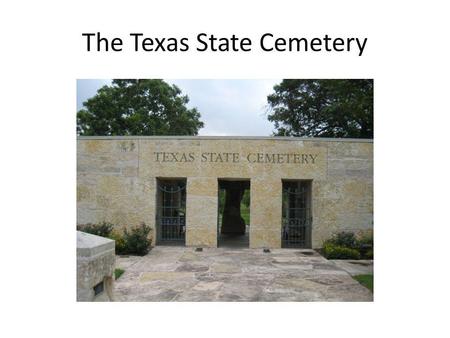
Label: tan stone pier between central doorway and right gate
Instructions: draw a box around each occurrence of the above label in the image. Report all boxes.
[250,177,282,248]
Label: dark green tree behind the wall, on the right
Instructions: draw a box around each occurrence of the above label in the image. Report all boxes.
[267,80,373,138]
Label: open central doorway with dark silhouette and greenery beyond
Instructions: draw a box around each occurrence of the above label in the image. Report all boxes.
[217,179,250,248]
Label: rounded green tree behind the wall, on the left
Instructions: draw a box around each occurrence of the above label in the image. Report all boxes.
[77,80,203,136]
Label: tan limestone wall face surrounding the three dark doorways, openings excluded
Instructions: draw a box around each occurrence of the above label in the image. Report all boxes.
[77,137,373,248]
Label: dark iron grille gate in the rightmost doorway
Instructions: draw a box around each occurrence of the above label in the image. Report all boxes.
[281,181,312,248]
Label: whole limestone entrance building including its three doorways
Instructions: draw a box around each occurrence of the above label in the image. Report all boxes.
[77,136,373,248]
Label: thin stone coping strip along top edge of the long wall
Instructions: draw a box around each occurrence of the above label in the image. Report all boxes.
[77,136,373,143]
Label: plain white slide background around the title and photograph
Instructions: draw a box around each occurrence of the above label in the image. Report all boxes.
[0,0,450,337]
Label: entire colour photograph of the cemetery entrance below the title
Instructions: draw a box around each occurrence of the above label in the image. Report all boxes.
[73,78,375,302]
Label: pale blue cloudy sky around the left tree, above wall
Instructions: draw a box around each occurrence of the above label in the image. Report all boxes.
[77,79,281,136]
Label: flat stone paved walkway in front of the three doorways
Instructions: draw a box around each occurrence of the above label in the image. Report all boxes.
[115,246,373,301]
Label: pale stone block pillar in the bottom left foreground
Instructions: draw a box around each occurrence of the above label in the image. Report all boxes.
[77,231,116,302]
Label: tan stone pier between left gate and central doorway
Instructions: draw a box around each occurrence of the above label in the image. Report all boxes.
[186,177,218,248]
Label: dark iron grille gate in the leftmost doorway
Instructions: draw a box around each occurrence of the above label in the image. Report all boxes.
[156,180,186,244]
